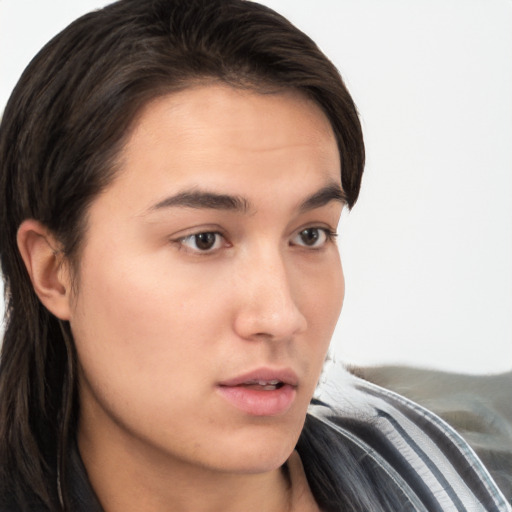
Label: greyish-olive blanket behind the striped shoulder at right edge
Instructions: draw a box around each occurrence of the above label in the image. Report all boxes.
[358,366,512,503]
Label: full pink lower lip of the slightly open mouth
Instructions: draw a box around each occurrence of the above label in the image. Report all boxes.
[217,384,296,416]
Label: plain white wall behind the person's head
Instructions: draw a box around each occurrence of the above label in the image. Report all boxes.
[0,0,512,373]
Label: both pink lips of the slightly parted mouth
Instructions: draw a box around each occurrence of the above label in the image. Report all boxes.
[217,368,299,416]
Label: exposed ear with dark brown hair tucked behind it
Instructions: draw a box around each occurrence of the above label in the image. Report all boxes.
[17,219,71,320]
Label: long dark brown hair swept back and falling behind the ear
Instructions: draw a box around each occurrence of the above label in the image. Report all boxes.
[0,0,364,510]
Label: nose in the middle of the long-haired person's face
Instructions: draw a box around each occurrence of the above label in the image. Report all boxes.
[234,249,307,340]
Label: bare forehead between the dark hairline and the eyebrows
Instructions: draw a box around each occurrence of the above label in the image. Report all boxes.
[102,85,341,213]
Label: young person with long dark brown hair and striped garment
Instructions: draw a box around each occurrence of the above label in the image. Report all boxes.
[0,0,509,512]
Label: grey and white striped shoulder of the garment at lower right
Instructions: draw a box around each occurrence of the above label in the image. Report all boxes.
[309,363,512,512]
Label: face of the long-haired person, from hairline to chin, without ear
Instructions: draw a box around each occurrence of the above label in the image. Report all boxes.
[70,85,344,472]
